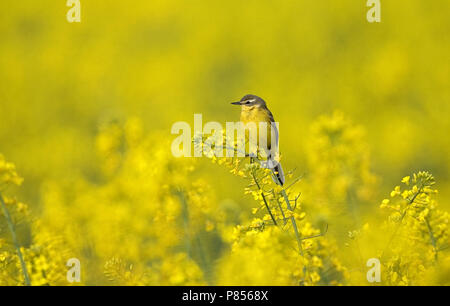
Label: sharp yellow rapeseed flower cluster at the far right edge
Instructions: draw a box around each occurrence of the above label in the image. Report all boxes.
[380,172,450,285]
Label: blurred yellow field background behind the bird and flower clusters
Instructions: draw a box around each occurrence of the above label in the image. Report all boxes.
[0,0,450,284]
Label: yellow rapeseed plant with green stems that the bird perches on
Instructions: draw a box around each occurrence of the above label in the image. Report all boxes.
[194,133,347,285]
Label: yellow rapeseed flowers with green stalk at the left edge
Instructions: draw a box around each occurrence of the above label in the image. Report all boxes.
[0,155,70,285]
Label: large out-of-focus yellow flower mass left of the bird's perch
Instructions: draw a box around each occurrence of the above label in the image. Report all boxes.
[36,119,223,285]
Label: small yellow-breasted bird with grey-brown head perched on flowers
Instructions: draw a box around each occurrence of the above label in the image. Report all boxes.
[231,94,285,186]
